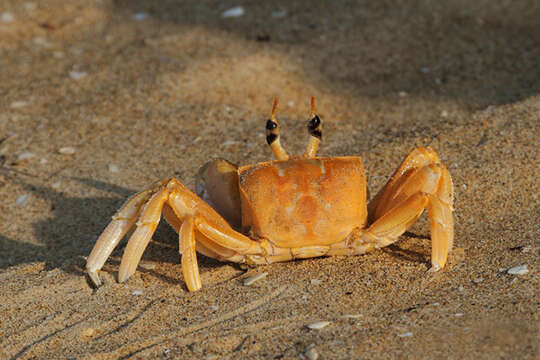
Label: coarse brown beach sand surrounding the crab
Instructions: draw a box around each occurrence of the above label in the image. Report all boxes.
[0,0,540,359]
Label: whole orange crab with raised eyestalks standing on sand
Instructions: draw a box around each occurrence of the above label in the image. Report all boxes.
[86,98,454,291]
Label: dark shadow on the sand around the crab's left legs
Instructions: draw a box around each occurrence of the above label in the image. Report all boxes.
[0,178,227,283]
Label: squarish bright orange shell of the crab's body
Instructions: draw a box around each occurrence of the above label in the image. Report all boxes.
[238,156,367,248]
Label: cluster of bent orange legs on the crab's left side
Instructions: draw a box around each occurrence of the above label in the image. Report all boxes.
[87,178,267,291]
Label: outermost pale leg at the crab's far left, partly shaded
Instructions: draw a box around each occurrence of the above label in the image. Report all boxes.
[86,189,152,286]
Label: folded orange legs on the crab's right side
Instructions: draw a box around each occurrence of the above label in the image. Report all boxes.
[357,147,454,271]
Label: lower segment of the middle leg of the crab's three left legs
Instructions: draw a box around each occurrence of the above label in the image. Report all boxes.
[118,188,169,282]
